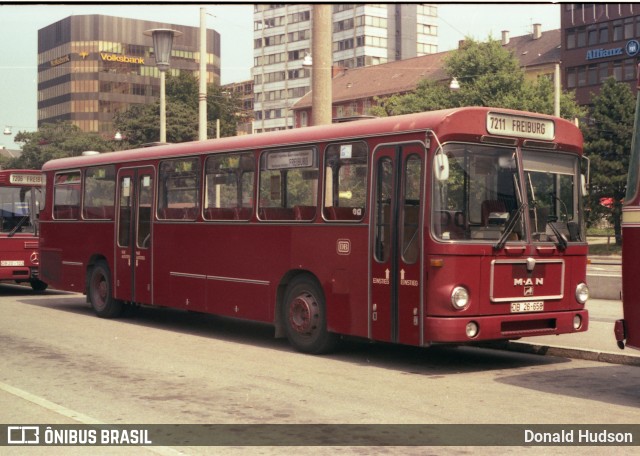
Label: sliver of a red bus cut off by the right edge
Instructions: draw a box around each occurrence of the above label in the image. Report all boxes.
[614,65,640,349]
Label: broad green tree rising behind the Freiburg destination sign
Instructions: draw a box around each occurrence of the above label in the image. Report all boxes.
[372,38,584,119]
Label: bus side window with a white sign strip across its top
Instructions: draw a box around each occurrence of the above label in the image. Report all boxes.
[258,149,318,221]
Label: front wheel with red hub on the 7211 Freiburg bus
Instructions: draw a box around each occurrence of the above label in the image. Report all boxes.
[283,276,338,354]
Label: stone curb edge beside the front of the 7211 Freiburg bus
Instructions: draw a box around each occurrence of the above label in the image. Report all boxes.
[482,341,640,367]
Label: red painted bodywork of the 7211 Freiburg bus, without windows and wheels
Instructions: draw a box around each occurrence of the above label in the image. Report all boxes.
[41,108,588,346]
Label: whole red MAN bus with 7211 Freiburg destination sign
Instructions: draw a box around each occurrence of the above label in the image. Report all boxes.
[41,108,588,353]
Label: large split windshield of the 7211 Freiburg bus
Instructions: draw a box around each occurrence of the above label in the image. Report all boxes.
[432,143,582,249]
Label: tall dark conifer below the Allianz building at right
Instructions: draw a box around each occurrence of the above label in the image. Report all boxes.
[582,78,635,245]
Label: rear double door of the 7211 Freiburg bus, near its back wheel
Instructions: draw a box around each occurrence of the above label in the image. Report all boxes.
[114,167,155,304]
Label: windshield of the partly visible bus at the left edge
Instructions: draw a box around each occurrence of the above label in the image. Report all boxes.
[0,187,42,234]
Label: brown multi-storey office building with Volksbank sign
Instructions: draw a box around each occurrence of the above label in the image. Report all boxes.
[38,15,220,137]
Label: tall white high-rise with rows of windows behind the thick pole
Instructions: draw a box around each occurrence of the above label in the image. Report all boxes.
[252,3,438,133]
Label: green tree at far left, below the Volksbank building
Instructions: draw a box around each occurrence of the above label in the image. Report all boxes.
[6,122,114,169]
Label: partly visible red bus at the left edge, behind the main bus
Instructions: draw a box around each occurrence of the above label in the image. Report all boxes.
[0,169,47,291]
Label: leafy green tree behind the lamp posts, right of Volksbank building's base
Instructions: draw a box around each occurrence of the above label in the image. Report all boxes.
[114,72,240,147]
